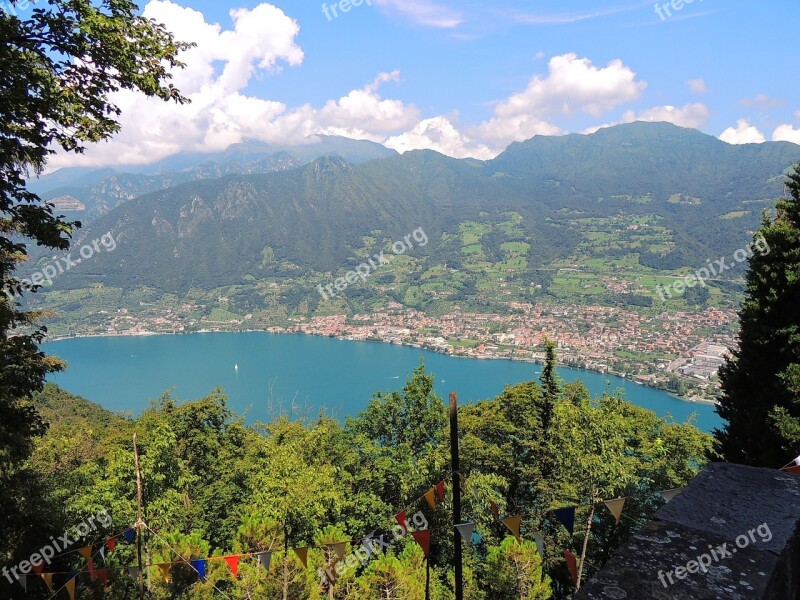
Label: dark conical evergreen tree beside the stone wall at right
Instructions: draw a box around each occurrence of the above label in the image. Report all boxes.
[715,164,800,468]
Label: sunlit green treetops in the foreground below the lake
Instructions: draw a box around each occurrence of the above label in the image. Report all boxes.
[0,354,710,600]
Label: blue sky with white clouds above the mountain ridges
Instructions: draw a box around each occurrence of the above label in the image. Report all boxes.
[48,0,800,170]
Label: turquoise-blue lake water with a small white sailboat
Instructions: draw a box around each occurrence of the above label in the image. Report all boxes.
[44,332,722,431]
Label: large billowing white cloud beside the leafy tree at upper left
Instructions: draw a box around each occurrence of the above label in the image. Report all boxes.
[48,0,420,169]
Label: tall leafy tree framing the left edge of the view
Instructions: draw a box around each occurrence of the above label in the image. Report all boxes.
[0,0,188,568]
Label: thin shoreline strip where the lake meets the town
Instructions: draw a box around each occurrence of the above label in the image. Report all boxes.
[43,329,717,406]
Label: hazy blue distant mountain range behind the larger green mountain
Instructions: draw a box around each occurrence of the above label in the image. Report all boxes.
[28,135,396,222]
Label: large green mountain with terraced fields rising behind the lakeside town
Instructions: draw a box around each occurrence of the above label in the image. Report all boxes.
[28,123,800,310]
